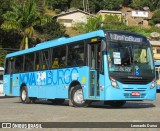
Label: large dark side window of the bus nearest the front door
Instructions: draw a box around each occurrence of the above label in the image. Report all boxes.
[67,44,84,66]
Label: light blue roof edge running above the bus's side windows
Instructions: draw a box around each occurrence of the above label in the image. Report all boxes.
[6,30,105,57]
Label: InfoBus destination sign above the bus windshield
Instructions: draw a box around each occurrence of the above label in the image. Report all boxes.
[110,33,142,42]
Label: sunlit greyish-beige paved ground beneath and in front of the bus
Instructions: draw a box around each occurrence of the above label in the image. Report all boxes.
[0,93,160,122]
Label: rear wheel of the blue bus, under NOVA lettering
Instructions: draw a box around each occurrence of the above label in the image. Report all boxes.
[20,86,31,104]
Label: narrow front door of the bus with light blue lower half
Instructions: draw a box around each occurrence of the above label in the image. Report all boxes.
[88,43,99,99]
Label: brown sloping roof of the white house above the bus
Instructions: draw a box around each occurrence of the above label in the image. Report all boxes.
[52,9,94,18]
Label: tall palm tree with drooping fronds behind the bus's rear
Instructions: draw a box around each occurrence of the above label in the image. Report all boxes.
[1,0,47,49]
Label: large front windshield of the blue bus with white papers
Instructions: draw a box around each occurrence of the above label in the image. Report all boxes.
[107,42,154,76]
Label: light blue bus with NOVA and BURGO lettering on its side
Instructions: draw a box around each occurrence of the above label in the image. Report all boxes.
[4,30,156,107]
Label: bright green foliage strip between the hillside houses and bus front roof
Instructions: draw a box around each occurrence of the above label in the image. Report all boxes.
[76,15,160,36]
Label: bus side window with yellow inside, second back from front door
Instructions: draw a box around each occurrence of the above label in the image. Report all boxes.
[52,46,66,68]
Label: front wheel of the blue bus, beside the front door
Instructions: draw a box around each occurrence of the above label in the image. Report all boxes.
[70,85,89,107]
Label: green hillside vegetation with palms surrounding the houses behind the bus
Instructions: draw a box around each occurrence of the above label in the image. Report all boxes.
[0,0,160,66]
